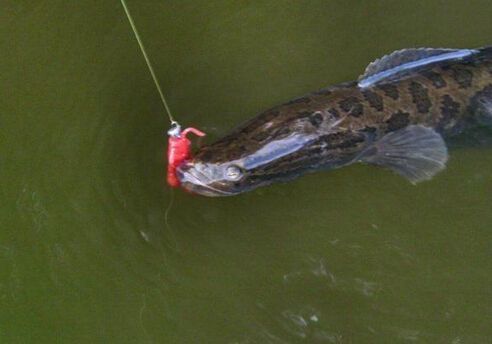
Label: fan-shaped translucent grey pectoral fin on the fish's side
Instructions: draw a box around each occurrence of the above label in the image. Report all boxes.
[358,125,448,184]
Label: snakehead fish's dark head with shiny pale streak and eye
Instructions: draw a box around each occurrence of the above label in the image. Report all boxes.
[177,112,320,196]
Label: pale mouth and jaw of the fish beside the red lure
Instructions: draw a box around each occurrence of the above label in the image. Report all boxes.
[176,163,235,197]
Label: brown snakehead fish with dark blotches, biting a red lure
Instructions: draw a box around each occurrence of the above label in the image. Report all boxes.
[177,46,492,197]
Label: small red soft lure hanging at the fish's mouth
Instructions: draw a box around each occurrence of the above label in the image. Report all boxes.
[167,124,205,188]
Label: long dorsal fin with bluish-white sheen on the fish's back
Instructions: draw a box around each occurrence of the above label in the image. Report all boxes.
[358,48,478,88]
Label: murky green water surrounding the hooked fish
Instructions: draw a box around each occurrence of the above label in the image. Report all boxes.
[0,0,492,344]
